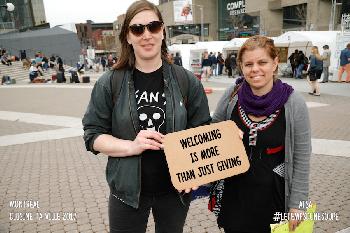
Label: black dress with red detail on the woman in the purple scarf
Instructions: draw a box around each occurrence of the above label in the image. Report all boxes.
[218,104,286,233]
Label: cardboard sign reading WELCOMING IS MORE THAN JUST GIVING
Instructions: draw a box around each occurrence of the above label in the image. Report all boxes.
[164,121,249,190]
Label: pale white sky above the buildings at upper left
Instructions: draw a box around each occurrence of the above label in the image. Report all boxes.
[44,0,158,27]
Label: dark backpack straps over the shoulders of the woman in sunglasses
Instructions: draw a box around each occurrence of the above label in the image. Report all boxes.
[111,64,189,109]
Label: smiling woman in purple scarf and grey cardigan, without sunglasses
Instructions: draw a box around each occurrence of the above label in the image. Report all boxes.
[209,36,311,233]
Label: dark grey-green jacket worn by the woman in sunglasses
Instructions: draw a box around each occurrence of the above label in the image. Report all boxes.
[83,62,211,208]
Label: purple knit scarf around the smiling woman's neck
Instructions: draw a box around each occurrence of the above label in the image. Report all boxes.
[236,79,294,116]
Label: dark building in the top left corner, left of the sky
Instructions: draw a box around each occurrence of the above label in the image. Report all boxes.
[0,0,50,33]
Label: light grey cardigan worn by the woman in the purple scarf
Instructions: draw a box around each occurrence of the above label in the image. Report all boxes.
[213,85,311,211]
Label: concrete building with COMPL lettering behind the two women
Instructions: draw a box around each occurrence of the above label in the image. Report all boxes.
[113,0,344,51]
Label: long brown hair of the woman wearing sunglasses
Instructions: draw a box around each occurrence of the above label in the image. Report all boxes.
[113,0,168,69]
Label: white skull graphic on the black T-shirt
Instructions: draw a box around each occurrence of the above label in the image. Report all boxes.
[137,105,165,132]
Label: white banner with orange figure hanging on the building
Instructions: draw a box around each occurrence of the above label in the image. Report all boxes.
[173,0,194,24]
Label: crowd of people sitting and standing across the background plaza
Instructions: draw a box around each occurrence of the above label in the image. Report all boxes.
[0,41,350,86]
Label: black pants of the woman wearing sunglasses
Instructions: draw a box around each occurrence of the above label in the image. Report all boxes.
[108,193,190,233]
